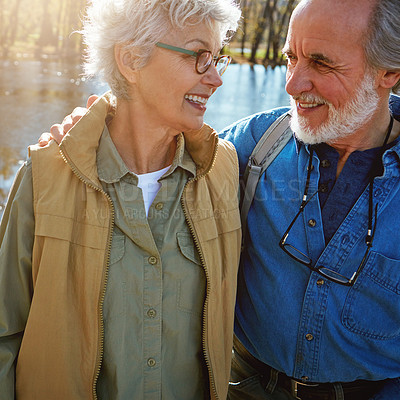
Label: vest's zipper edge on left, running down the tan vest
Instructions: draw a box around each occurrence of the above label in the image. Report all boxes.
[60,149,115,400]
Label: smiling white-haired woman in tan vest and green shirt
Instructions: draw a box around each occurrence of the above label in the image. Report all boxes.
[0,0,240,400]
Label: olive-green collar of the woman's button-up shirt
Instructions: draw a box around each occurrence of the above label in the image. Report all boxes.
[97,125,196,183]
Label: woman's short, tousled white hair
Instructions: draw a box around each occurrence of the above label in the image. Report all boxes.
[81,0,240,98]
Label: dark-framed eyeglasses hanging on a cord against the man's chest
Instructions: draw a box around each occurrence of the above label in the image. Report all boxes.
[279,147,378,286]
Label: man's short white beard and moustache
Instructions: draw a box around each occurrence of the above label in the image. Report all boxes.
[290,72,379,144]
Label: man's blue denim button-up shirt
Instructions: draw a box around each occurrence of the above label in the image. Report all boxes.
[221,96,400,400]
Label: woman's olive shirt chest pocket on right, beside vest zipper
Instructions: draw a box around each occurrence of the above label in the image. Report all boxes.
[176,232,206,315]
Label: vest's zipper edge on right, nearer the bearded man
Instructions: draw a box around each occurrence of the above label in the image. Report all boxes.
[181,142,219,399]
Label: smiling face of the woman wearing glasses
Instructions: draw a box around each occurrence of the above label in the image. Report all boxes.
[133,24,222,132]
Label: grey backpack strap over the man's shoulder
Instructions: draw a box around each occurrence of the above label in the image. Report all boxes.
[240,111,292,248]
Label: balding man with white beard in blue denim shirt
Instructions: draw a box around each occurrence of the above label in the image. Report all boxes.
[222,0,400,400]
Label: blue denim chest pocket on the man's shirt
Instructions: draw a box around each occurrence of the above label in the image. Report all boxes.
[342,251,400,340]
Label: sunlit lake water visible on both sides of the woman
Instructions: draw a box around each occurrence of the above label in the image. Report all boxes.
[0,61,289,216]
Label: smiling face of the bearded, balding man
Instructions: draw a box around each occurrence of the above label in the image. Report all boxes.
[284,0,379,143]
